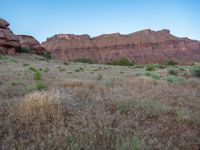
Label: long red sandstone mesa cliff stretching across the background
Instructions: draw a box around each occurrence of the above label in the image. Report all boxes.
[42,29,200,64]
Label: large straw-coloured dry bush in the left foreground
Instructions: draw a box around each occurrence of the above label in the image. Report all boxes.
[13,91,61,124]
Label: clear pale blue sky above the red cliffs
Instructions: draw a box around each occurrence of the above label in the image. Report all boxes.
[0,0,200,42]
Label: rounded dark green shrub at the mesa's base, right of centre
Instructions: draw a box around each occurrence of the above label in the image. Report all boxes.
[107,58,135,66]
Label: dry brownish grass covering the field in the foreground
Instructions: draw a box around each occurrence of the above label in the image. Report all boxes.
[0,54,200,150]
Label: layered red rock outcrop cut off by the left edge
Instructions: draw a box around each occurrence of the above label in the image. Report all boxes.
[0,18,20,54]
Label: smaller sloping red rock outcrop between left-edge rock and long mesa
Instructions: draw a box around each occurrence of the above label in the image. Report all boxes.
[18,35,46,55]
